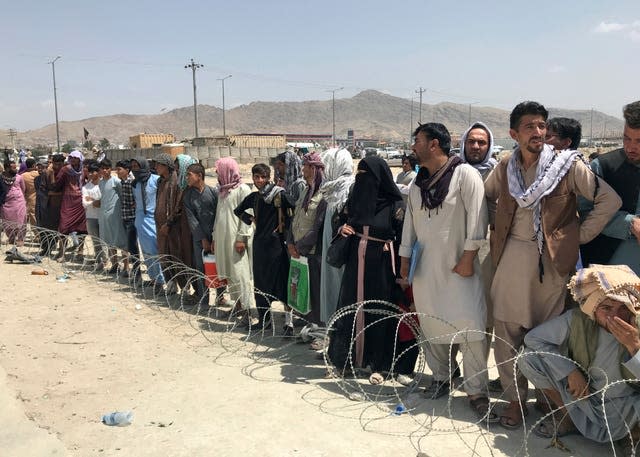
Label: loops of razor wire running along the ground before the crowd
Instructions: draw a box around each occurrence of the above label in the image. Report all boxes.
[0,220,640,456]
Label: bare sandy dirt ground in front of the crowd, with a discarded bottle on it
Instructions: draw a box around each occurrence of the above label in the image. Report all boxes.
[0,156,611,457]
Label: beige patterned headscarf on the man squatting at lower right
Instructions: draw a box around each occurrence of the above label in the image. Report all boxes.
[568,264,640,320]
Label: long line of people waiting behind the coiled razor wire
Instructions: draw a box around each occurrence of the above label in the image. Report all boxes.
[0,101,640,452]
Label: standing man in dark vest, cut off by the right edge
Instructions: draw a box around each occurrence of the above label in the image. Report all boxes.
[581,100,640,275]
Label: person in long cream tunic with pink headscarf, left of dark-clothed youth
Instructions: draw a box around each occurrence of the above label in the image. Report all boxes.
[213,157,255,318]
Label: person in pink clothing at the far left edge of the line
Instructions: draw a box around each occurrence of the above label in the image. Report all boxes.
[0,160,27,246]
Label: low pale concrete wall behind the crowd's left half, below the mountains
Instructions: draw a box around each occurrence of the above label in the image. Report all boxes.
[105,146,282,168]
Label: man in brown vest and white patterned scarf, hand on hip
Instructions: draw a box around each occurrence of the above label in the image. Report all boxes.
[485,101,620,429]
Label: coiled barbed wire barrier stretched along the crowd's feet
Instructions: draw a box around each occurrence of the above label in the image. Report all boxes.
[0,220,640,456]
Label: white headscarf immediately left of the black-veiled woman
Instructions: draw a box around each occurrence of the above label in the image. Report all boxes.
[320,148,353,206]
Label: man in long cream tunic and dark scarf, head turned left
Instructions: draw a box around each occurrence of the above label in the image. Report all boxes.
[400,123,498,422]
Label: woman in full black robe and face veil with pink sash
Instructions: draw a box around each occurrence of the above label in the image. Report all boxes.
[329,156,402,383]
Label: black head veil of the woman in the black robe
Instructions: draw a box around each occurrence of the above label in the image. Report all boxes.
[348,156,402,226]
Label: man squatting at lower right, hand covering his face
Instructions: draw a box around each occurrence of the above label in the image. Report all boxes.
[518,265,640,456]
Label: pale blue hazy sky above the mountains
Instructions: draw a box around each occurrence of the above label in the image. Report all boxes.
[0,0,640,130]
